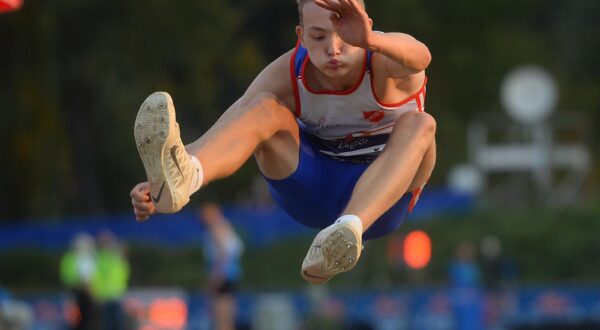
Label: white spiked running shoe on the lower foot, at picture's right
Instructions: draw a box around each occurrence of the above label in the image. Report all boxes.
[301,221,362,284]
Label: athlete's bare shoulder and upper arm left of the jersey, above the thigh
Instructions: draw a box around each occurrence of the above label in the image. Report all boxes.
[241,49,294,111]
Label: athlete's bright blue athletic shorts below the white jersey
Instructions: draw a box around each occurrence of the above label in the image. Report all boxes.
[263,129,420,240]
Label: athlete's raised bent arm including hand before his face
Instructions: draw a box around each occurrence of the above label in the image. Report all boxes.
[314,0,431,78]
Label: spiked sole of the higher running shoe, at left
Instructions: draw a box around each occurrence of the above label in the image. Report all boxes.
[134,92,175,213]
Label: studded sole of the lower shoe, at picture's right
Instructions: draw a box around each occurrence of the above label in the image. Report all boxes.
[302,226,362,284]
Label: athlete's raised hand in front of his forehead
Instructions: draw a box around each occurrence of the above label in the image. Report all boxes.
[313,0,373,49]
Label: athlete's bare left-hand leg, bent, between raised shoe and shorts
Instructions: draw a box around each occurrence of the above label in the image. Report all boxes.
[186,93,300,183]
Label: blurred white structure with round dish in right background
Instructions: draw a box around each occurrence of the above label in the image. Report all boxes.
[455,65,591,204]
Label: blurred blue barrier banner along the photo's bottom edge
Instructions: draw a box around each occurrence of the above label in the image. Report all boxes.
[10,286,600,330]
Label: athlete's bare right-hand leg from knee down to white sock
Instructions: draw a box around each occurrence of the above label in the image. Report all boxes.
[343,112,436,230]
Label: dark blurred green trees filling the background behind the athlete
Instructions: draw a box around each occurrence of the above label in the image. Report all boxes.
[0,0,600,222]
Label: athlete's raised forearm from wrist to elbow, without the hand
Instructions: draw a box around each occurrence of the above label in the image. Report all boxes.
[369,31,431,73]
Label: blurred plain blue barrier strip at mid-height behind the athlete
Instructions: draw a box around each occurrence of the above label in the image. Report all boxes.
[0,187,473,251]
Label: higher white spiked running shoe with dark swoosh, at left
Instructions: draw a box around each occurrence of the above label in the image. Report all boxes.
[134,92,199,213]
